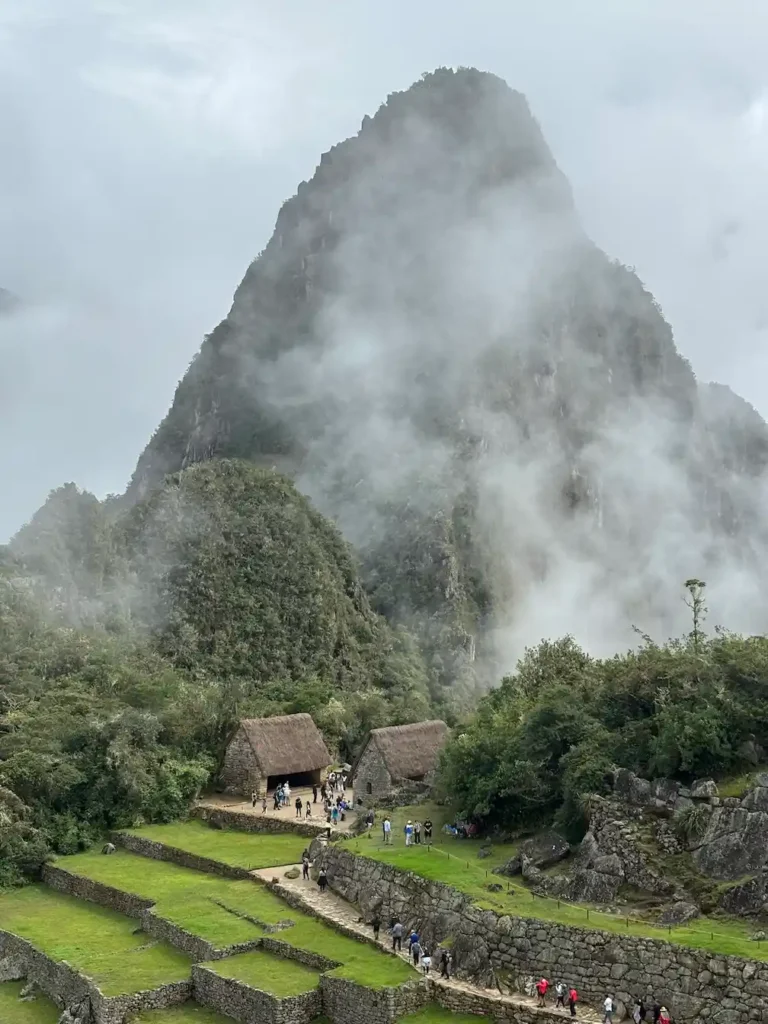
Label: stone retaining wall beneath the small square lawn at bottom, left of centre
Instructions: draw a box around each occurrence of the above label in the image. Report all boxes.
[193,967,323,1024]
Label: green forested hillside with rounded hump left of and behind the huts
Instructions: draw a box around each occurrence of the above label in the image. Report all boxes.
[0,462,428,884]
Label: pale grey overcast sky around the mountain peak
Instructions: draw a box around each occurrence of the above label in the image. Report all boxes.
[0,0,768,541]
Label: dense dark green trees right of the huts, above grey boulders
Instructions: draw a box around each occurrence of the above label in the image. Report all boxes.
[443,581,768,838]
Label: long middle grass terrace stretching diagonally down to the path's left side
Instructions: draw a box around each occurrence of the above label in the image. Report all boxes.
[57,850,413,987]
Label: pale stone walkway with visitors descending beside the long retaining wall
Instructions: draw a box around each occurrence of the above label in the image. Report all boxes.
[252,864,602,1024]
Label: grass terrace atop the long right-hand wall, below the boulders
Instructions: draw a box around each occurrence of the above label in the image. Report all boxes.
[344,805,768,961]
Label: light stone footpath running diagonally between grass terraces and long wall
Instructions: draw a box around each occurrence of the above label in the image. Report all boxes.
[256,864,602,1024]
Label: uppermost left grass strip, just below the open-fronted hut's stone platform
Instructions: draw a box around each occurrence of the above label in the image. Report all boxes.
[126,818,309,870]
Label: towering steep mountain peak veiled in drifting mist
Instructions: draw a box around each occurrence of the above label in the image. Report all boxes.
[129,70,768,696]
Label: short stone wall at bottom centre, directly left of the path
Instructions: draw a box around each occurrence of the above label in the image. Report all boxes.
[321,975,430,1024]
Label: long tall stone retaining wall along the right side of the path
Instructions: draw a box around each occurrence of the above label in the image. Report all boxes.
[318,846,768,1024]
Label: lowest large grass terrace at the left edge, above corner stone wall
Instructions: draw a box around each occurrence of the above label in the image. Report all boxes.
[0,884,189,995]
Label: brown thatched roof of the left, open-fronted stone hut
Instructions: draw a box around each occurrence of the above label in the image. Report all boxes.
[240,715,331,775]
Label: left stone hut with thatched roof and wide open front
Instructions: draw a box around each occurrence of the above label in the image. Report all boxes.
[222,714,331,795]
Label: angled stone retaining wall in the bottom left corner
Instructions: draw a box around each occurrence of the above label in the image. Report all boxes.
[0,932,193,1024]
